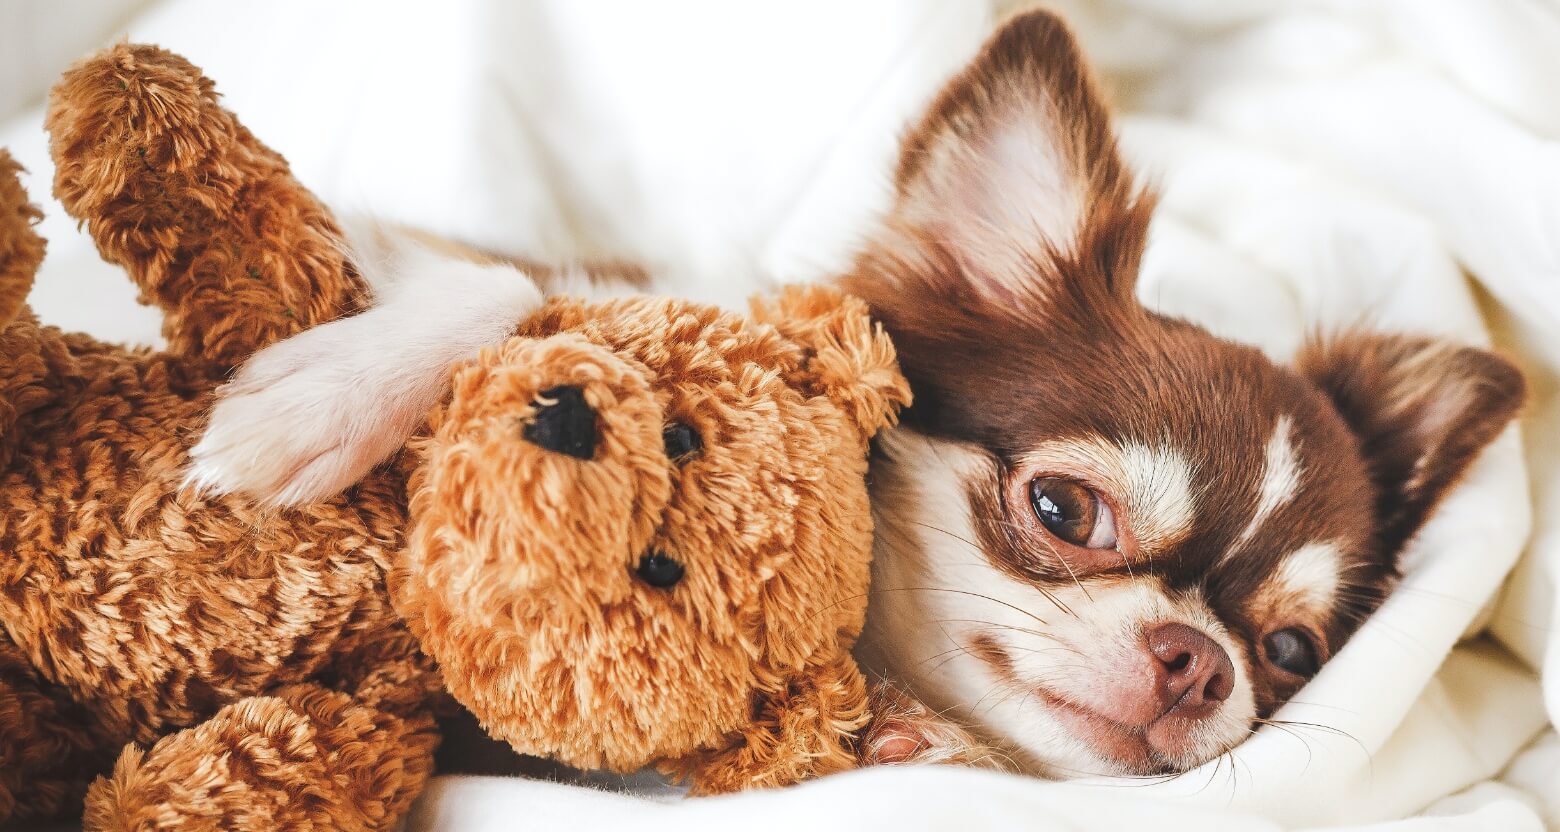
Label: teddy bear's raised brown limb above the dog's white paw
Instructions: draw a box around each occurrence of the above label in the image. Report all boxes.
[47,44,363,367]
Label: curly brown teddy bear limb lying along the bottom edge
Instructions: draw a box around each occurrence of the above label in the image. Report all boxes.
[83,668,438,832]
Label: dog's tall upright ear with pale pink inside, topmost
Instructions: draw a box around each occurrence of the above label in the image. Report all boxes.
[850,11,1151,309]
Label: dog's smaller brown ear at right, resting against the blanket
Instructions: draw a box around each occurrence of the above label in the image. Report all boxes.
[1298,332,1527,551]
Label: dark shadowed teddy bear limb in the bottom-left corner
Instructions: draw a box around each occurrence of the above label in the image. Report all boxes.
[0,632,112,829]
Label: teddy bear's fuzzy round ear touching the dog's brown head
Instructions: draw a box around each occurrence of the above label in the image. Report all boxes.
[752,286,909,439]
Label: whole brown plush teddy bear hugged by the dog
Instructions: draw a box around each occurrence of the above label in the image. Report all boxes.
[0,45,908,829]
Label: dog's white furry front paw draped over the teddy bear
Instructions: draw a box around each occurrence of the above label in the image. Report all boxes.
[186,240,543,506]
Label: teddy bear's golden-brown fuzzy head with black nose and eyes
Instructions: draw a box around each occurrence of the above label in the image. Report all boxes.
[395,287,909,790]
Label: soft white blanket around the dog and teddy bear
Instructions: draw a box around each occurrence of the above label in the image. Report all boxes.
[0,0,1560,830]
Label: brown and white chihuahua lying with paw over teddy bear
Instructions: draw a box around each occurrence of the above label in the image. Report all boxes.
[192,12,1524,776]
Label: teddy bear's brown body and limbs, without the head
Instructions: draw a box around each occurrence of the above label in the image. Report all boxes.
[0,47,440,827]
